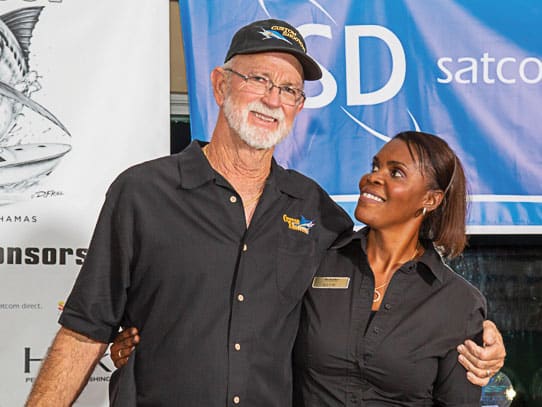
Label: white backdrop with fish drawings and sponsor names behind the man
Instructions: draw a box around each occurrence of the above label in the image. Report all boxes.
[0,0,169,407]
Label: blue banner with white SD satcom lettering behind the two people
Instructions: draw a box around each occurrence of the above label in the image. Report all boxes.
[179,0,542,234]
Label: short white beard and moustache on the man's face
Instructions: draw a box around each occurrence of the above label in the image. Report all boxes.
[222,95,292,150]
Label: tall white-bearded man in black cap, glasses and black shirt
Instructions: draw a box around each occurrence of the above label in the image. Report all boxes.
[28,20,503,407]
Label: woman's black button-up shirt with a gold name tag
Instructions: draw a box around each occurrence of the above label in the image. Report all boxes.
[294,229,486,407]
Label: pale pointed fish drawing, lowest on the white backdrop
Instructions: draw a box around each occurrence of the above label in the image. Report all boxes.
[0,143,71,188]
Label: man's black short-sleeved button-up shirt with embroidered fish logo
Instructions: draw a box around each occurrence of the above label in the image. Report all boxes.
[60,142,352,407]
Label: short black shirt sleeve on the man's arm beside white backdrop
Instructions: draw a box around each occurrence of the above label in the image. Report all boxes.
[59,175,135,343]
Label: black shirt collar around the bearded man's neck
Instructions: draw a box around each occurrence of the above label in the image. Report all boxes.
[178,140,308,198]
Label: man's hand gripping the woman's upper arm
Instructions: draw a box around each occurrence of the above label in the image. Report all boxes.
[457,321,506,386]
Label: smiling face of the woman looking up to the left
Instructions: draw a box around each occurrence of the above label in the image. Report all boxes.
[355,139,434,229]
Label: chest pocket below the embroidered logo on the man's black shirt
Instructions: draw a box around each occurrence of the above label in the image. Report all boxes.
[276,235,321,301]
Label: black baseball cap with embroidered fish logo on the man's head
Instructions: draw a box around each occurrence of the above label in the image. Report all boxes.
[224,19,322,81]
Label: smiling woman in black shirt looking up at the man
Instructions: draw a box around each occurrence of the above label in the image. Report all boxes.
[294,132,486,407]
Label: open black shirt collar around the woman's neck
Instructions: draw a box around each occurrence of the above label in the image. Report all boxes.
[331,226,448,282]
